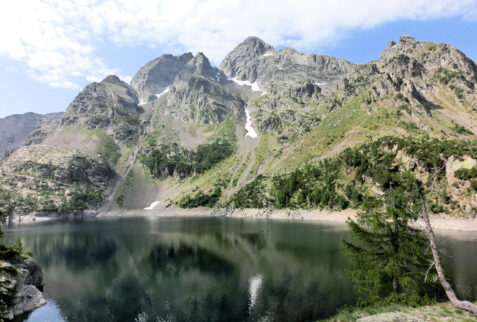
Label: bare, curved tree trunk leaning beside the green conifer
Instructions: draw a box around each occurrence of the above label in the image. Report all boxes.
[419,191,477,315]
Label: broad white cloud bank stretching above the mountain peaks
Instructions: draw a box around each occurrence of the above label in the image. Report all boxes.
[0,0,477,88]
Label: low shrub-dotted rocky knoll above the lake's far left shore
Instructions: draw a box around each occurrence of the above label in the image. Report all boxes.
[0,145,114,213]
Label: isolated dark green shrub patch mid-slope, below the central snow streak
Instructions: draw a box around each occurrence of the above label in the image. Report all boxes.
[141,139,234,178]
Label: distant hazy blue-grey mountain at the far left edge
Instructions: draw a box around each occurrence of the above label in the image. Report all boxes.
[0,113,63,155]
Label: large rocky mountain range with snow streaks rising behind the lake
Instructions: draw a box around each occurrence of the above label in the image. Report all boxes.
[0,36,477,215]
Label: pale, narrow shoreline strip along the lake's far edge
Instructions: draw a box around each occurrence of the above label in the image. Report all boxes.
[8,207,477,233]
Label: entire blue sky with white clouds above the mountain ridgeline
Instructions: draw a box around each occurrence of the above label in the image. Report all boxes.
[0,0,477,117]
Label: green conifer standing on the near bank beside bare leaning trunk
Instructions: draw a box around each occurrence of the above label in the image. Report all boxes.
[343,173,436,305]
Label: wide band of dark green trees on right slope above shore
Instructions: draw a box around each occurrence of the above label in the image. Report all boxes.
[229,136,477,211]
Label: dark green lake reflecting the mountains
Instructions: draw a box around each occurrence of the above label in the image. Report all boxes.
[5,217,477,322]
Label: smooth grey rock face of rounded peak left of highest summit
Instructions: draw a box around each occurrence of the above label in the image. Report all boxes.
[131,53,194,100]
